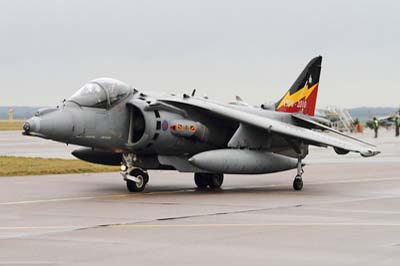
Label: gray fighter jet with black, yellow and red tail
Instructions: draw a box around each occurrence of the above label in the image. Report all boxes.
[23,56,379,192]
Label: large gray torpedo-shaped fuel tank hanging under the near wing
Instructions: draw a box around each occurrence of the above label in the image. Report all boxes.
[189,149,297,174]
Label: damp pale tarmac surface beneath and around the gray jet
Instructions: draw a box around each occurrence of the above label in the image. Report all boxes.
[0,129,400,265]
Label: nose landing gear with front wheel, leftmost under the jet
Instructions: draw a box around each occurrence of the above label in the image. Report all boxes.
[121,154,149,192]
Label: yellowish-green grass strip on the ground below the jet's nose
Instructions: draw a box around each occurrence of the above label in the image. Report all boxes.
[0,156,119,176]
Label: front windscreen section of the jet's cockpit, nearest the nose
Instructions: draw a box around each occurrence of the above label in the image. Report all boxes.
[68,83,107,108]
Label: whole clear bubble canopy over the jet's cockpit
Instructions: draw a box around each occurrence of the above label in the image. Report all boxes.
[68,78,131,108]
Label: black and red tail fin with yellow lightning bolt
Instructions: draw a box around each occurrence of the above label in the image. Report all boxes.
[275,56,322,116]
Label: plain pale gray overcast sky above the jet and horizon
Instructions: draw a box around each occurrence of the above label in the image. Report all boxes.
[0,0,400,107]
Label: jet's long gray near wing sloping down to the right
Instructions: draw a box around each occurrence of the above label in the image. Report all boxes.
[160,97,380,157]
